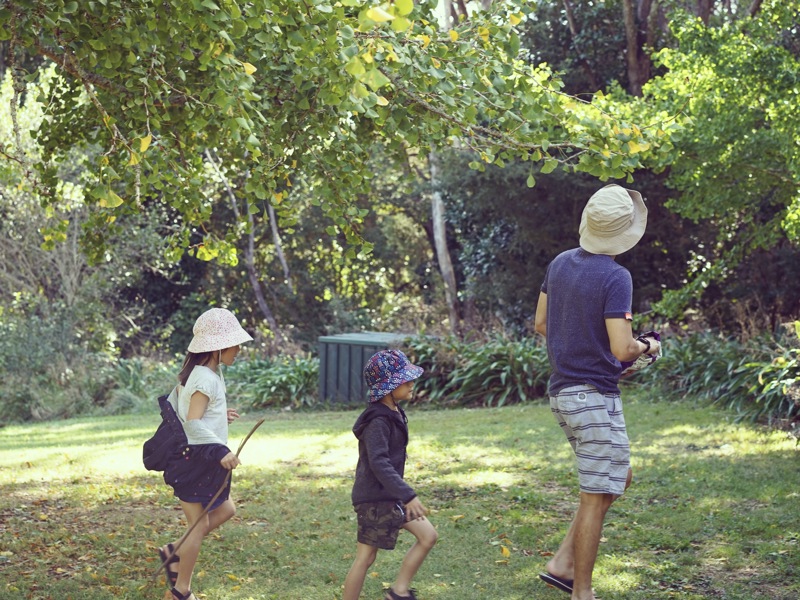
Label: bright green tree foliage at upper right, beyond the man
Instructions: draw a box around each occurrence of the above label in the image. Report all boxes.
[645,2,800,315]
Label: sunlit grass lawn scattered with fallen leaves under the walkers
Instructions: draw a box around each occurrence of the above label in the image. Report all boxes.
[0,390,800,600]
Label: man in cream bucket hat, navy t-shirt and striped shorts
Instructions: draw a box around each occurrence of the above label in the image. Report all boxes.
[535,185,659,600]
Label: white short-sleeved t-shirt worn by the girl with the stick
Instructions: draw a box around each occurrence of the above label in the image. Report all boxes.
[169,365,228,446]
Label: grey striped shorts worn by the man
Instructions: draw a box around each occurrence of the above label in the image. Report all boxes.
[550,385,631,496]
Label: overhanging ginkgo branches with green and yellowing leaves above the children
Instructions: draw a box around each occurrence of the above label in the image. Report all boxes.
[0,0,678,263]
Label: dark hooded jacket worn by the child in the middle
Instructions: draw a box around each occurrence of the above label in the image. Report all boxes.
[351,402,416,504]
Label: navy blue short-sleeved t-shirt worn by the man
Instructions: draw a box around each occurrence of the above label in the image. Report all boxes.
[541,248,633,395]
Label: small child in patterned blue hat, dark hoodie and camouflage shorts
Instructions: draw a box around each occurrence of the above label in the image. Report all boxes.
[342,350,438,600]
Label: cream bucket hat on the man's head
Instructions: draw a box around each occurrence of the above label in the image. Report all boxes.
[579,184,647,256]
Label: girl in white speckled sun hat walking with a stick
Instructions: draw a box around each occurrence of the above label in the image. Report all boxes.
[159,308,253,600]
